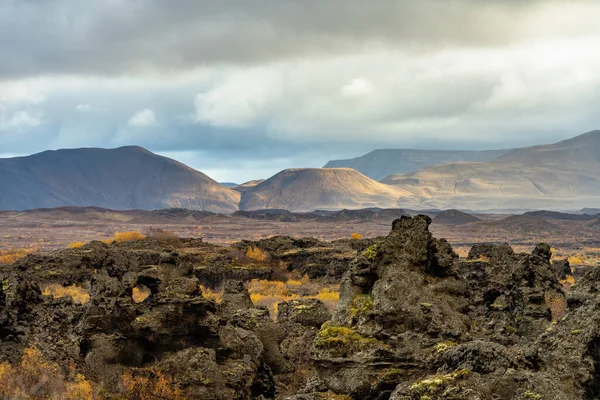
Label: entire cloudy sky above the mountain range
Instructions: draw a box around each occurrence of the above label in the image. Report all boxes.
[0,0,600,183]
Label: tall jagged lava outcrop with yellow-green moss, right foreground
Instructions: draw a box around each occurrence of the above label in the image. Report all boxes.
[313,216,576,400]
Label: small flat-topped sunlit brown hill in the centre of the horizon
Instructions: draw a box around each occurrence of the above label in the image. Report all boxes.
[240,168,410,211]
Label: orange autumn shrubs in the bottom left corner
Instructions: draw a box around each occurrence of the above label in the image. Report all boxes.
[0,347,98,400]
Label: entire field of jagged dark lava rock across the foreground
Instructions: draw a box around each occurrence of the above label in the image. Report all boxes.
[0,216,600,400]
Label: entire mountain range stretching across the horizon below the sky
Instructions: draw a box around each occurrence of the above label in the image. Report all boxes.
[0,131,600,213]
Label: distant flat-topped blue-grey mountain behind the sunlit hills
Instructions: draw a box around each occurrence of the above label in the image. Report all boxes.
[324,149,509,180]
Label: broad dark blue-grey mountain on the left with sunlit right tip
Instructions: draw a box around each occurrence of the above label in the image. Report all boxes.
[0,146,240,212]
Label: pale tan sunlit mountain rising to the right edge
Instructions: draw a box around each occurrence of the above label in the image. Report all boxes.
[381,131,600,210]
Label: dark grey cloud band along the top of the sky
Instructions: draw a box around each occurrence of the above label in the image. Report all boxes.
[0,0,588,77]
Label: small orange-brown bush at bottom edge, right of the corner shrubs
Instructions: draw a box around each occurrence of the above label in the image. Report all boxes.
[121,369,186,400]
